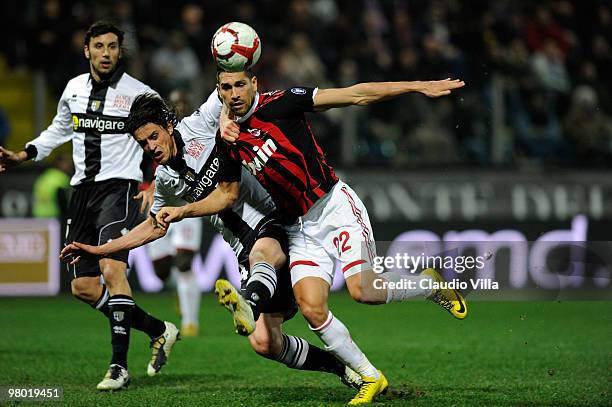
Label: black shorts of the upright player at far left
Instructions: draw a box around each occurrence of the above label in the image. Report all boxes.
[66,179,140,278]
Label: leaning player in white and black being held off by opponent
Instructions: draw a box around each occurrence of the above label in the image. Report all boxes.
[62,92,361,387]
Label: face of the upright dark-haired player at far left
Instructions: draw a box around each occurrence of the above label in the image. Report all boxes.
[84,33,121,81]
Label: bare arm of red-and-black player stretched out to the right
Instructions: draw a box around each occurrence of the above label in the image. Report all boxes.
[313,78,465,111]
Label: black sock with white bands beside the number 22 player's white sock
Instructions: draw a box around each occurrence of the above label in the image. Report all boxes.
[277,334,345,377]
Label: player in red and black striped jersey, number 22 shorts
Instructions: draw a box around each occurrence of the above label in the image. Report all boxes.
[157,67,467,405]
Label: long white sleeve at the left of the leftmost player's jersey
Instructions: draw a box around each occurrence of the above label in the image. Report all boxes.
[26,85,74,161]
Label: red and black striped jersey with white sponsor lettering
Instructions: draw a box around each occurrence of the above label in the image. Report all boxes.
[222,87,338,222]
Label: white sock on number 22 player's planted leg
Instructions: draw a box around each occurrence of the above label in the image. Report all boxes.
[310,311,380,379]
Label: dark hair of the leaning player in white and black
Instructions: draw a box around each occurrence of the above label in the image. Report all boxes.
[125,93,178,136]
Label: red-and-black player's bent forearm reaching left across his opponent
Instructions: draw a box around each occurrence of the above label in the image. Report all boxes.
[155,181,240,228]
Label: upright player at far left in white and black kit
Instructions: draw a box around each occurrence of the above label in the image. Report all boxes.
[0,22,179,390]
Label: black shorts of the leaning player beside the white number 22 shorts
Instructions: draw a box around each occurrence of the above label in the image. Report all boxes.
[240,214,298,321]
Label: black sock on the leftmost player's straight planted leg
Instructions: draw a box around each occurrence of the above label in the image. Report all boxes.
[108,294,134,369]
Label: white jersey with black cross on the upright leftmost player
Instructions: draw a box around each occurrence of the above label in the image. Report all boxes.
[26,68,154,186]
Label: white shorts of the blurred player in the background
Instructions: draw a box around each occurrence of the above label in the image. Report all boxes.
[147,218,202,260]
